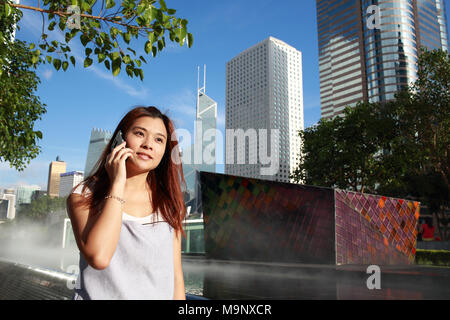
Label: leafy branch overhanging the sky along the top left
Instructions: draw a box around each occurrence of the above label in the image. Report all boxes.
[0,0,193,80]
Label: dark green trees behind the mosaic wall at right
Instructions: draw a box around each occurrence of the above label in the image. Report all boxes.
[292,49,450,238]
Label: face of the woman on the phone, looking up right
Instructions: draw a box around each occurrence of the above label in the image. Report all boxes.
[125,116,167,171]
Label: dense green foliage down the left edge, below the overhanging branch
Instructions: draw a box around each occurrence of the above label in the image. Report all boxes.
[0,6,46,171]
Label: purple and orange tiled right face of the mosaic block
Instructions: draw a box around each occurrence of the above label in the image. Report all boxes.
[335,189,419,264]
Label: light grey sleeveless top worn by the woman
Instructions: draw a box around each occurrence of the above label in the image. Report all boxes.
[74,220,174,300]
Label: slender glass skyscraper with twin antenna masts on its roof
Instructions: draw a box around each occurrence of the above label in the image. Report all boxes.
[182,66,217,212]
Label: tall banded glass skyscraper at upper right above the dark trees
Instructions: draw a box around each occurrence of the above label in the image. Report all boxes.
[316,0,448,119]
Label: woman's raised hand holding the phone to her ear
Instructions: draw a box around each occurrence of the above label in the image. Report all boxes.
[105,141,134,186]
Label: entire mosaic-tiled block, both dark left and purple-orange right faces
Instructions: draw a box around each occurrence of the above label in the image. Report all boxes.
[200,172,419,265]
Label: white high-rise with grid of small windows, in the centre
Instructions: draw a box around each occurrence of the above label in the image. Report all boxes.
[225,37,304,182]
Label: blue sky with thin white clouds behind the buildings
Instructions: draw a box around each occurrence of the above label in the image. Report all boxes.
[0,0,450,189]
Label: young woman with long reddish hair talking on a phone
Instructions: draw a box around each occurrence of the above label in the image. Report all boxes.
[67,107,186,299]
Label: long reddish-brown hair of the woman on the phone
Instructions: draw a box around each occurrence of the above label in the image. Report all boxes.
[74,106,186,235]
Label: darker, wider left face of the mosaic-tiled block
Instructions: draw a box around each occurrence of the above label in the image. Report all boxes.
[200,172,336,264]
